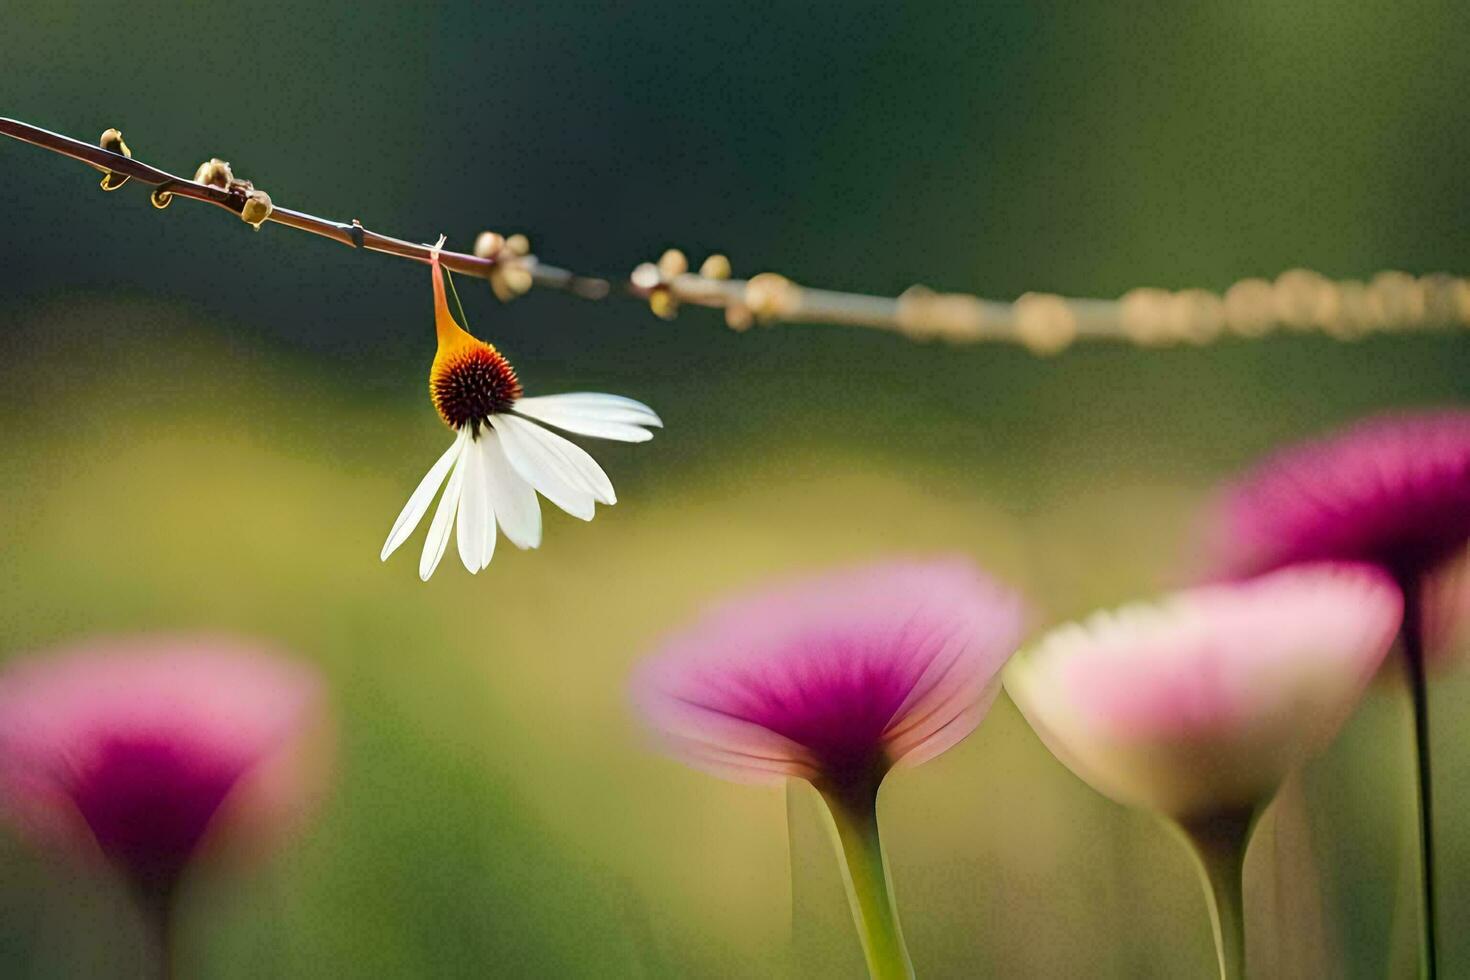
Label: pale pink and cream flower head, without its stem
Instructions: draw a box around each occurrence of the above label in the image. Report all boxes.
[1005,564,1402,820]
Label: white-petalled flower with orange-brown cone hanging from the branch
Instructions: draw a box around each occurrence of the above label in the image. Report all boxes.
[379,239,663,582]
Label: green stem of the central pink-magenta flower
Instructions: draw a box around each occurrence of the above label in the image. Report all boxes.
[819,782,914,980]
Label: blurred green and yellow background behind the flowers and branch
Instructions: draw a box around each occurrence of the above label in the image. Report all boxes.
[0,0,1470,977]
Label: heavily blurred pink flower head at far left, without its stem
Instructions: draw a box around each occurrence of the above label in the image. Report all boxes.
[0,638,325,904]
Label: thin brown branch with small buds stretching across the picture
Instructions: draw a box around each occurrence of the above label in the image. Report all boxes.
[0,119,1470,354]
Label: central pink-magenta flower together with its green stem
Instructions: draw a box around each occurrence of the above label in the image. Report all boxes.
[634,560,1022,977]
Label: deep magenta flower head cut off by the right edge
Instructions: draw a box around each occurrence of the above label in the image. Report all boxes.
[1216,410,1470,582]
